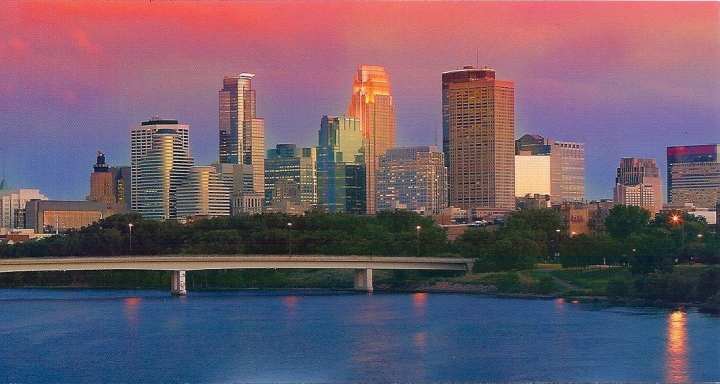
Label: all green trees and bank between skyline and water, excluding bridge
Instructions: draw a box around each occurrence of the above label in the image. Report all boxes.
[0,210,720,313]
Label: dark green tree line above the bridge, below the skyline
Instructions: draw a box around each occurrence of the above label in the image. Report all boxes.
[0,205,720,274]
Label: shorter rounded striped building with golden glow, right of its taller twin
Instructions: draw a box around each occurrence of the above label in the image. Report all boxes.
[177,166,232,221]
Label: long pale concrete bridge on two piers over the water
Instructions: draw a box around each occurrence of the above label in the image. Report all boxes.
[0,255,474,296]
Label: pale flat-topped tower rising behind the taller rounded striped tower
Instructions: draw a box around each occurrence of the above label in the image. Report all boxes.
[130,117,190,212]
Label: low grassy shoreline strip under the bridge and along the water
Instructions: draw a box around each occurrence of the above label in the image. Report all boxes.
[0,264,720,314]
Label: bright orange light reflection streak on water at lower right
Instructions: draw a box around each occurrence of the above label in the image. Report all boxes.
[665,310,690,383]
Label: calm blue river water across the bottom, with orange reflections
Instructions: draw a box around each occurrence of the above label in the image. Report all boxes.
[0,289,720,382]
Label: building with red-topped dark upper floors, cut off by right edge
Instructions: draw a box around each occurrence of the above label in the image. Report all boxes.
[667,144,720,209]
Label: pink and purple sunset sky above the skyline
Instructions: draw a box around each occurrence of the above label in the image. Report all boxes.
[0,1,720,200]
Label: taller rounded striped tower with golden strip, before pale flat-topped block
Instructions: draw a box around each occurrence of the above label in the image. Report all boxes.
[133,128,194,220]
